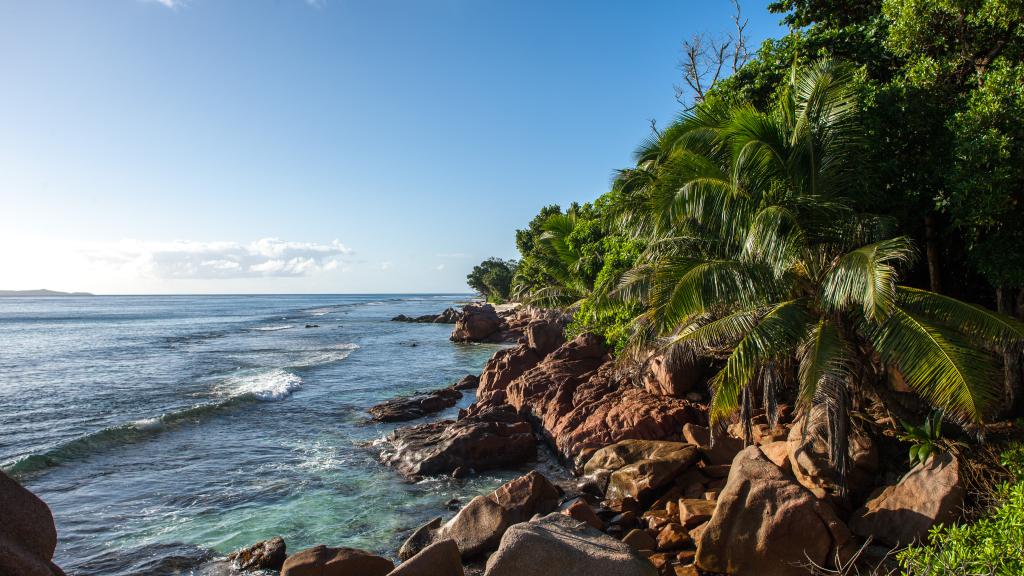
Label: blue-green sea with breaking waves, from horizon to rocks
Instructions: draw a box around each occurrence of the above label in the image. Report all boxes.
[0,295,544,576]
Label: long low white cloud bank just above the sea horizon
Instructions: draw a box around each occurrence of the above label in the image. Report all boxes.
[78,238,351,279]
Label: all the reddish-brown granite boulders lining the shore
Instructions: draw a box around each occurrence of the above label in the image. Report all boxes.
[0,304,965,576]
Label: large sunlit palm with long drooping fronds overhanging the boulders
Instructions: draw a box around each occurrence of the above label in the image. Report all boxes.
[615,59,1024,470]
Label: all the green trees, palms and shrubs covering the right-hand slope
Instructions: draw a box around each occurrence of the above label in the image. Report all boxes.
[462,0,1024,574]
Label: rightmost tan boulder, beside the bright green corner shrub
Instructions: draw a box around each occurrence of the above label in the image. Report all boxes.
[850,454,965,546]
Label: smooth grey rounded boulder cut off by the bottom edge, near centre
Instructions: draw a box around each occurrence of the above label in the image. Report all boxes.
[484,512,657,576]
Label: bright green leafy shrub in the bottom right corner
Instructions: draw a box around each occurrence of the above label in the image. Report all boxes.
[897,445,1024,576]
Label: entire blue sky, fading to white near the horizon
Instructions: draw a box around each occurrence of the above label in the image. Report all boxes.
[0,0,784,294]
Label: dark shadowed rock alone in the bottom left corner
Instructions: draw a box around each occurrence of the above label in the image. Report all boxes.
[0,471,63,576]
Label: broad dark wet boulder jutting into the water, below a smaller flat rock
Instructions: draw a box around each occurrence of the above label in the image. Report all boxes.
[382,408,537,478]
